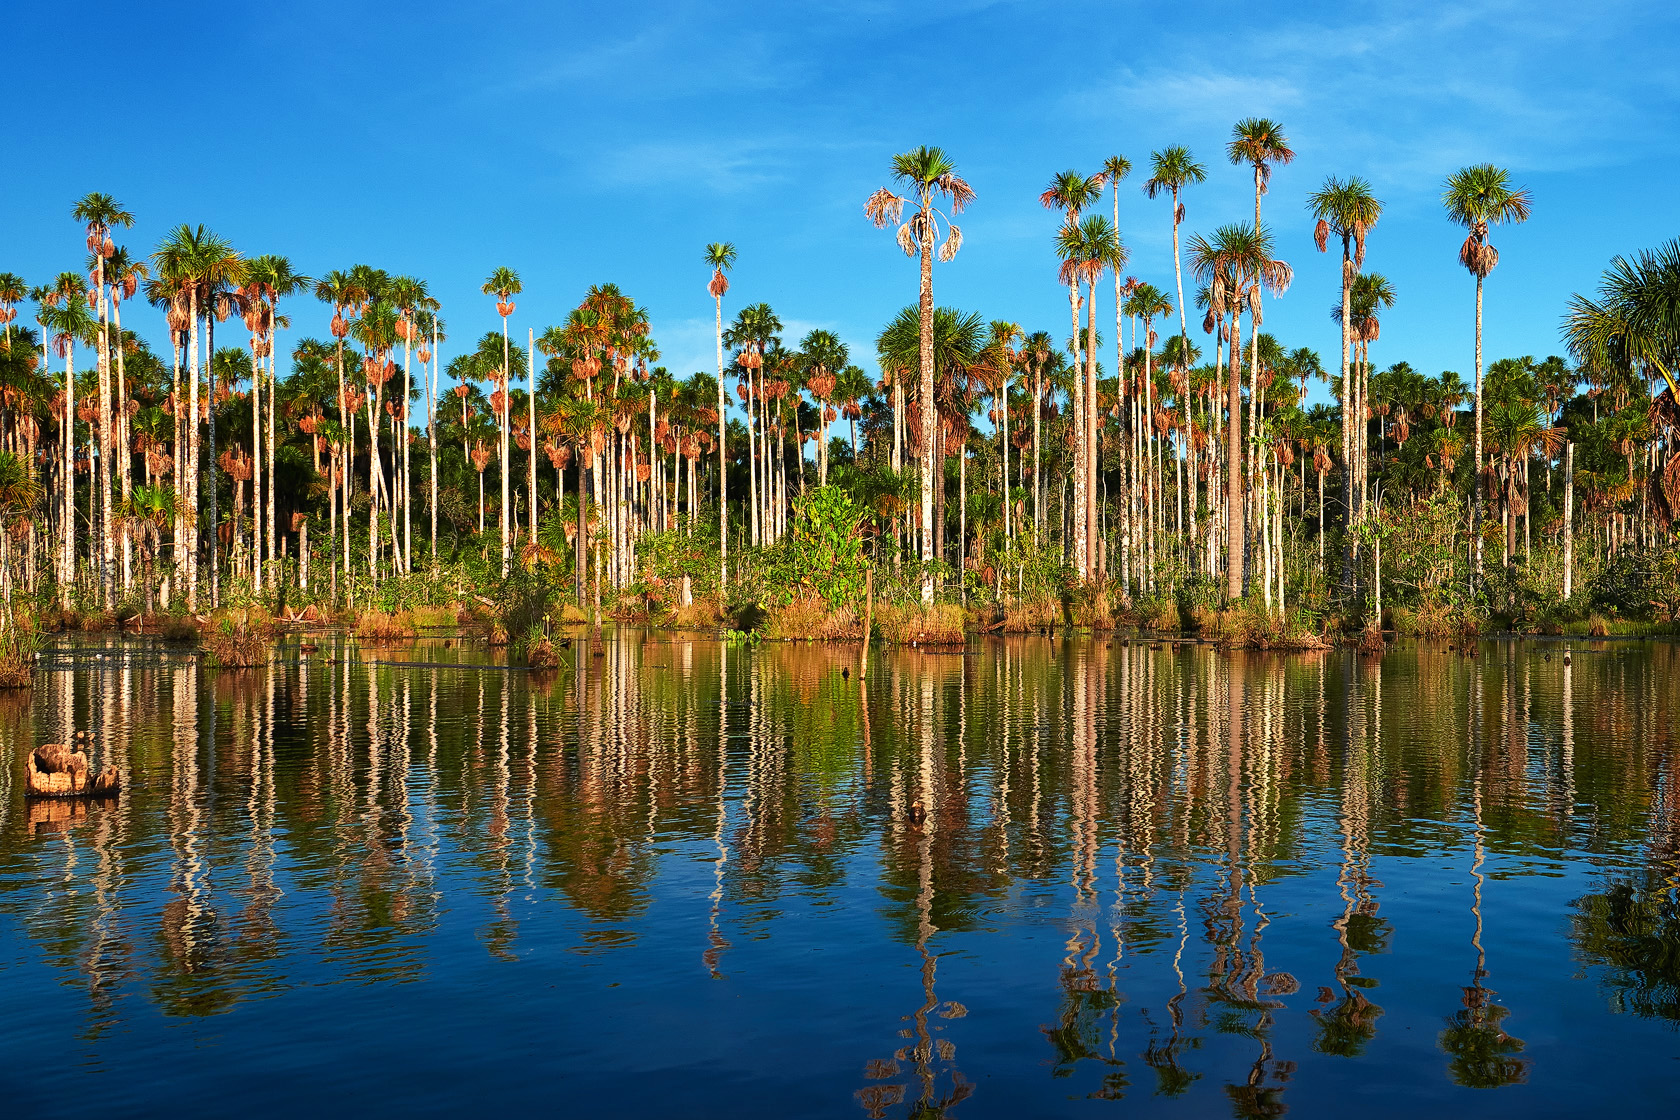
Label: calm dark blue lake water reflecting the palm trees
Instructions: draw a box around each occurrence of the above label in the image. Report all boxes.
[0,633,1680,1117]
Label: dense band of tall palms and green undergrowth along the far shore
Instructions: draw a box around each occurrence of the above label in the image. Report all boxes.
[0,119,1680,653]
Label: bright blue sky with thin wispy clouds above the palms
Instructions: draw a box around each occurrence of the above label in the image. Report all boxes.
[13,0,1680,411]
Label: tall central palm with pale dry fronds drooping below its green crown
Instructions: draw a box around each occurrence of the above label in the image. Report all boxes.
[864,144,974,604]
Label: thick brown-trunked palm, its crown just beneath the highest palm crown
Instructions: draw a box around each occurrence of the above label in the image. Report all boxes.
[1189,223,1294,601]
